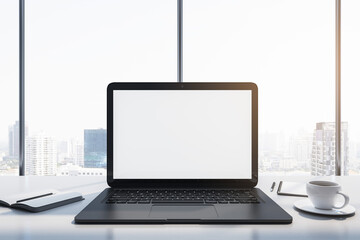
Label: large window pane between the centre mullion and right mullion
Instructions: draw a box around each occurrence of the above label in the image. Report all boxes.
[184,0,335,175]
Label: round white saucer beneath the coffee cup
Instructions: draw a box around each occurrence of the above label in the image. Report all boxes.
[294,198,355,216]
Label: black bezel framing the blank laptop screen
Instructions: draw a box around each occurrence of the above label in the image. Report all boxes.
[107,82,258,189]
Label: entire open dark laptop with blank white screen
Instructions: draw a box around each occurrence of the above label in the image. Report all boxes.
[75,83,292,224]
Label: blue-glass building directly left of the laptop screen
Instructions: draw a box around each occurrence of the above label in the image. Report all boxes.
[84,128,106,168]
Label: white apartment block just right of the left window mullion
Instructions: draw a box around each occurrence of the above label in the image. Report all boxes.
[25,134,57,176]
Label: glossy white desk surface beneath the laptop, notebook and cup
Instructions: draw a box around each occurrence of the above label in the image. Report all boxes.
[0,176,360,240]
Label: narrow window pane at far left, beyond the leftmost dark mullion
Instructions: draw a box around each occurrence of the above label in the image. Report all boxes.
[0,0,19,175]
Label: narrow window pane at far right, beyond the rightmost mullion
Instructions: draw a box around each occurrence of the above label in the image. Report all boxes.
[341,0,360,175]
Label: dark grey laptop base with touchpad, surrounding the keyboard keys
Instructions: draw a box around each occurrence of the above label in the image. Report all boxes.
[75,188,292,224]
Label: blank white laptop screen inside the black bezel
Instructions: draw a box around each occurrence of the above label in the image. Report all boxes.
[113,90,252,179]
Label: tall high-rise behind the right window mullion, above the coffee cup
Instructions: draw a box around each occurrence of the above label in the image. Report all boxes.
[311,122,349,176]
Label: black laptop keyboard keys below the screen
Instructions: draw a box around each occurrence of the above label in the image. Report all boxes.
[105,190,259,204]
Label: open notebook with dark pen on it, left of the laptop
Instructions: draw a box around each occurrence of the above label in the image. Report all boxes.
[0,189,84,212]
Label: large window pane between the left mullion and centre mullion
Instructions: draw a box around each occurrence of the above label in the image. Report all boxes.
[26,0,177,175]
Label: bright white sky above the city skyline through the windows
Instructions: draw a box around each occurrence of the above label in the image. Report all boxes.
[0,0,360,148]
